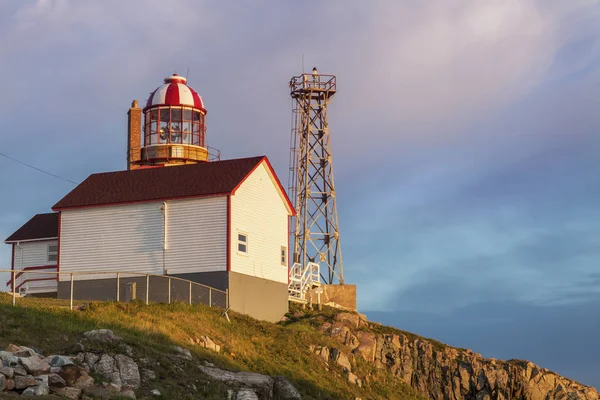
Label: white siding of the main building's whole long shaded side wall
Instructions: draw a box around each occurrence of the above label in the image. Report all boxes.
[60,196,227,280]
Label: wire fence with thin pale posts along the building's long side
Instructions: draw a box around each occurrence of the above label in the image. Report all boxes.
[0,267,229,309]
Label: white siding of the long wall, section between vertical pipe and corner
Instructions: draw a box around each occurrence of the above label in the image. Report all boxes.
[166,196,227,274]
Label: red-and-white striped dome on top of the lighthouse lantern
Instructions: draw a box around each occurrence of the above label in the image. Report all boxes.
[146,74,206,113]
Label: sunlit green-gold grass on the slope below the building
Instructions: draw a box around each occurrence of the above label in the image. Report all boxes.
[0,294,426,399]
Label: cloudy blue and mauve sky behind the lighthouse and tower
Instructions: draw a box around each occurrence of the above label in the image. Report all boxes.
[0,0,600,387]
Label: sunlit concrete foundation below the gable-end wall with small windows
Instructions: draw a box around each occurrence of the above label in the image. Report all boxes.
[229,272,288,322]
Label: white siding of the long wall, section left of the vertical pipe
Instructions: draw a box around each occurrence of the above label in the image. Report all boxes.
[59,202,164,281]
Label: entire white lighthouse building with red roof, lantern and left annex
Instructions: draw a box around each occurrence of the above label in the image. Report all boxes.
[6,75,294,321]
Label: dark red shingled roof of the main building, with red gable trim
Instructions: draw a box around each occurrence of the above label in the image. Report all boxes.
[52,156,293,213]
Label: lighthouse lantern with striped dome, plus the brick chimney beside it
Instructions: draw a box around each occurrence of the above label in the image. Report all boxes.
[127,74,209,170]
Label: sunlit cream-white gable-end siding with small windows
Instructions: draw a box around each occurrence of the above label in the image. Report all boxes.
[230,161,289,283]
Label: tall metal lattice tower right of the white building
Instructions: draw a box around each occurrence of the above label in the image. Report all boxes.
[289,68,344,284]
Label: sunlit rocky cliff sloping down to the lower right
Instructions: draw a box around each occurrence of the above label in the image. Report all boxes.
[296,312,600,400]
